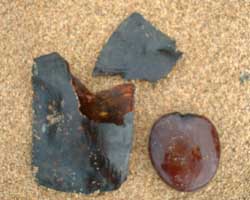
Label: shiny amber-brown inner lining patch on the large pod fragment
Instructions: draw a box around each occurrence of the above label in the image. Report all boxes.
[72,77,134,125]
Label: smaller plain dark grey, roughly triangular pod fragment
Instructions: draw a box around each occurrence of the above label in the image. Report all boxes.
[93,13,182,82]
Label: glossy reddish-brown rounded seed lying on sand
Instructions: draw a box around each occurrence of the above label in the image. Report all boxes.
[149,113,220,191]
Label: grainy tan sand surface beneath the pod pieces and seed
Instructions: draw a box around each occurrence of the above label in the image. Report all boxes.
[0,0,250,200]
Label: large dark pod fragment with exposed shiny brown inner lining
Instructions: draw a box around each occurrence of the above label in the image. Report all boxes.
[32,53,134,194]
